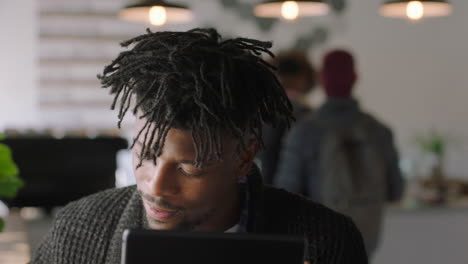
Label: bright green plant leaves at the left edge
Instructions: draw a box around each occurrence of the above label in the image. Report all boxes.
[0,134,24,232]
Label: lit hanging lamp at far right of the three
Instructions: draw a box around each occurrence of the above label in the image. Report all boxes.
[380,0,452,20]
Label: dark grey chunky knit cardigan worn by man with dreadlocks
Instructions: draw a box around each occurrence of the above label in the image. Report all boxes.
[31,169,367,264]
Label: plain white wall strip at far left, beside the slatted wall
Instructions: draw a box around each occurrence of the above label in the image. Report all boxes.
[0,0,38,131]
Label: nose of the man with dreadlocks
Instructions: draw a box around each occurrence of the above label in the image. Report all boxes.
[148,159,180,197]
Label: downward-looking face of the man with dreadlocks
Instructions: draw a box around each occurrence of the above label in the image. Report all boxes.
[133,119,252,231]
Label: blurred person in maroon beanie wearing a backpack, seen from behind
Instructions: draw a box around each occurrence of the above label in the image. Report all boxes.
[275,50,403,256]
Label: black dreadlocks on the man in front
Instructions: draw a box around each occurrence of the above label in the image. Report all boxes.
[98,28,293,167]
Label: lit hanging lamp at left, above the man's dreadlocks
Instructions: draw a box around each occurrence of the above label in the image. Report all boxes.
[118,0,193,26]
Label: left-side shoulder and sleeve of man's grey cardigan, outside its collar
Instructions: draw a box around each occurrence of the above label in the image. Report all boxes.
[31,187,135,263]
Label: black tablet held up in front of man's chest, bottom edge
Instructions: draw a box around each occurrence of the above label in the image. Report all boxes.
[121,229,304,264]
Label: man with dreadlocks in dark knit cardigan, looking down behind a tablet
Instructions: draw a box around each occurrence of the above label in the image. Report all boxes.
[32,29,367,264]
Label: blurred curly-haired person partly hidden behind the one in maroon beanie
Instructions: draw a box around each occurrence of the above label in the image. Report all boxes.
[257,50,316,184]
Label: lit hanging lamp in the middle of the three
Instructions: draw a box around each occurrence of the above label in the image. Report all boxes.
[254,0,329,20]
